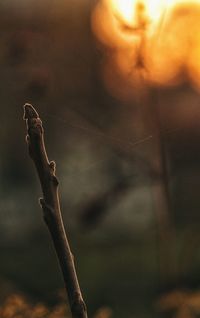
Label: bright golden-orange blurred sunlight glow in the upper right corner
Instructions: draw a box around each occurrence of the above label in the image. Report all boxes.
[92,0,200,96]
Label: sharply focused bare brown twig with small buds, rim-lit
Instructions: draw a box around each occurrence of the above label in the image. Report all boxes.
[24,104,87,318]
